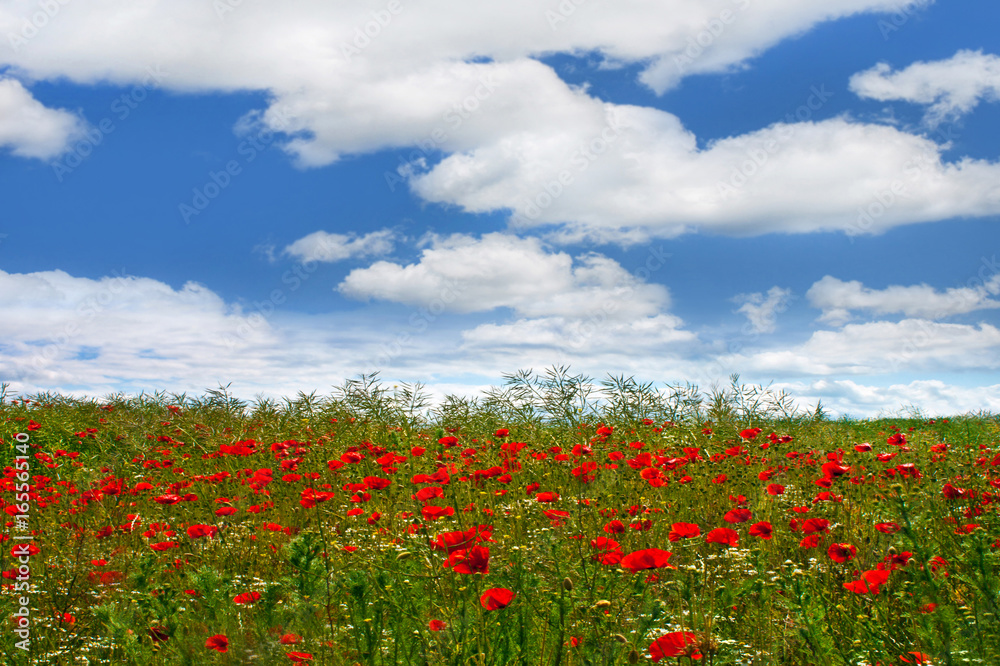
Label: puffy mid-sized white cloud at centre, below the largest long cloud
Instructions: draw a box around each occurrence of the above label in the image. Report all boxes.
[338,233,670,319]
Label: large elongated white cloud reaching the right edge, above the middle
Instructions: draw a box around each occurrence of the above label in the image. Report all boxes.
[413,111,1000,241]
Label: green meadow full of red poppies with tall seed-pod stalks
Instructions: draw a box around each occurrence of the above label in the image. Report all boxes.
[0,369,1000,666]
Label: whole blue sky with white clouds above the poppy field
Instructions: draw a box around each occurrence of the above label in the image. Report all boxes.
[0,0,1000,416]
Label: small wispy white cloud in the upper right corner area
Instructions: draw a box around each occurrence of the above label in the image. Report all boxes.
[850,51,1000,125]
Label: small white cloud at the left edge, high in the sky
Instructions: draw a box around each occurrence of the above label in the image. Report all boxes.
[0,78,86,160]
